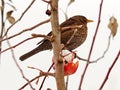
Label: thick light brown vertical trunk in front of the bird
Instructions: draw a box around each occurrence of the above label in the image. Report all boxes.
[50,0,65,90]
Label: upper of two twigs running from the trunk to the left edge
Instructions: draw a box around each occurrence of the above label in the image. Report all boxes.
[0,19,50,42]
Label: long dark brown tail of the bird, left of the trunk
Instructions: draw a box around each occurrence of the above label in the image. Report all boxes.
[20,42,52,61]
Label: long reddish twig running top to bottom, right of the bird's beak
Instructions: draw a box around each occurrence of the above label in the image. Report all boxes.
[78,0,103,90]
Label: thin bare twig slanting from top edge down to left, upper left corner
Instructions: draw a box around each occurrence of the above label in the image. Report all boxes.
[3,0,35,37]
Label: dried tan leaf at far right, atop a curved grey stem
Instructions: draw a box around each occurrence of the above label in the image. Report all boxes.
[108,16,118,37]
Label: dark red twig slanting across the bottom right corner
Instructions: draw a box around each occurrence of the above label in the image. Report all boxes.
[99,50,120,90]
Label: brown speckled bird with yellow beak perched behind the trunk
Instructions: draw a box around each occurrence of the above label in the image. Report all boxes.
[20,15,93,61]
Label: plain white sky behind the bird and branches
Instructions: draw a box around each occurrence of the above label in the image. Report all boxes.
[0,0,120,90]
